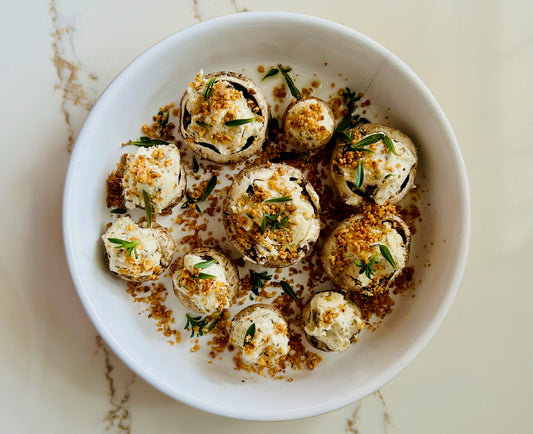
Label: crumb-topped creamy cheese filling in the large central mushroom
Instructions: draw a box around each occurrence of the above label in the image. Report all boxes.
[231,168,317,257]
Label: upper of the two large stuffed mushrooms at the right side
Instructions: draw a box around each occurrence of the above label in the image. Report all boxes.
[330,124,418,207]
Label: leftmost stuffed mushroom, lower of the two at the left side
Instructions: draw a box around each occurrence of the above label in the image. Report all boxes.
[102,217,175,283]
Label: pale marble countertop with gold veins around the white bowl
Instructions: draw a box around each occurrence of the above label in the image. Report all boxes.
[0,0,533,434]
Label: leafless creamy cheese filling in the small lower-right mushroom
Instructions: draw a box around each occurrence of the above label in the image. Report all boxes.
[304,291,365,351]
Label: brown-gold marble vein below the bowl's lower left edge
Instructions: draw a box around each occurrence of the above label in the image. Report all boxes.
[96,335,136,434]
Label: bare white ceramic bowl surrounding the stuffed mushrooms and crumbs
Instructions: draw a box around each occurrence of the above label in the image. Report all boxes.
[63,12,470,420]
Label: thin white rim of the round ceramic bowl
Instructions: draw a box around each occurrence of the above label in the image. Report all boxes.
[62,11,471,421]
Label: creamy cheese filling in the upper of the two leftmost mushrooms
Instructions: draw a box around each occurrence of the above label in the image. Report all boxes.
[122,145,181,213]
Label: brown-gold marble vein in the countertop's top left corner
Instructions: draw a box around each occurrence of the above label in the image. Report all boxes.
[49,0,98,152]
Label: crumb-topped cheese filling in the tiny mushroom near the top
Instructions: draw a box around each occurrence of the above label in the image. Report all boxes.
[286,99,335,144]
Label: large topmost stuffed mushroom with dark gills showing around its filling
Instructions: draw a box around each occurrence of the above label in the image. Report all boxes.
[179,71,268,164]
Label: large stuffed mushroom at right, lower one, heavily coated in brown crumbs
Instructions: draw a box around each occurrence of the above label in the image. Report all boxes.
[321,214,411,296]
